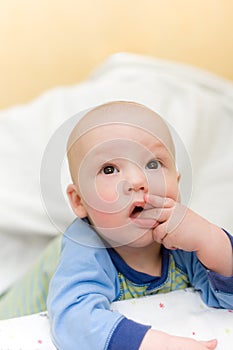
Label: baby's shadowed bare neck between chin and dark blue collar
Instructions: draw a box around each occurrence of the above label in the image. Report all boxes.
[114,243,162,276]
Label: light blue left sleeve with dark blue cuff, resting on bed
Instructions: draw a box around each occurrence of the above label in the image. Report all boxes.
[47,220,149,350]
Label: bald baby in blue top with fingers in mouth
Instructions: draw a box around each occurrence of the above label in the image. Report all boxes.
[47,101,233,350]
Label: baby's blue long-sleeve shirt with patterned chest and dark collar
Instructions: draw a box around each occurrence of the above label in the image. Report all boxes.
[47,219,233,350]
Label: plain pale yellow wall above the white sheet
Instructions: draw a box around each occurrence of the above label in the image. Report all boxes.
[0,0,233,108]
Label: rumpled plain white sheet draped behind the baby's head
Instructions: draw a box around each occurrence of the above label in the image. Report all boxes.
[0,53,233,294]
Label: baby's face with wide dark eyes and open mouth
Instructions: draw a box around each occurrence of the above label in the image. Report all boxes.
[72,115,178,246]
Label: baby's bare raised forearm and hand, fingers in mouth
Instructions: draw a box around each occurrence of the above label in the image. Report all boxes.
[147,195,233,276]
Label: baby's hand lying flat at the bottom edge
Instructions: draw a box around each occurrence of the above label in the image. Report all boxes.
[139,329,217,350]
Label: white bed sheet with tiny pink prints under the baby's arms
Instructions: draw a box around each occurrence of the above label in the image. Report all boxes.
[0,288,233,350]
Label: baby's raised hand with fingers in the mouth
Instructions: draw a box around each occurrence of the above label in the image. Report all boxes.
[146,195,210,251]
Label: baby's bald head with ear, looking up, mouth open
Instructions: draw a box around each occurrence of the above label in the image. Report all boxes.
[67,101,179,244]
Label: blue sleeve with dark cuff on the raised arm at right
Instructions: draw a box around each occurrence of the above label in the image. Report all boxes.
[174,230,233,309]
